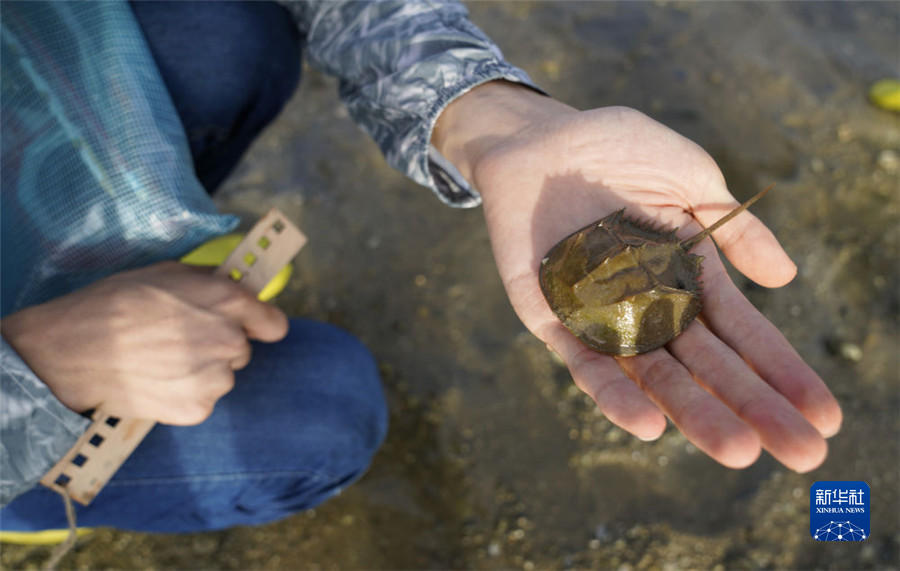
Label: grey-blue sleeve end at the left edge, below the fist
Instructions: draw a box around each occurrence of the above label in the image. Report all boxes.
[0,338,90,505]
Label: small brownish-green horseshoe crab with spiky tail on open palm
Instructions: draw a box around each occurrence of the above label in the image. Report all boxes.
[540,185,774,356]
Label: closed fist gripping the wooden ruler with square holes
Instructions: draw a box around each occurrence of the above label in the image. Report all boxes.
[0,262,287,425]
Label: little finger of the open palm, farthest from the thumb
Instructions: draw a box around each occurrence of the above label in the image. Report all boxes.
[546,323,666,440]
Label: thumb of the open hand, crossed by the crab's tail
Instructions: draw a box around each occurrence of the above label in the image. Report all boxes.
[693,183,797,287]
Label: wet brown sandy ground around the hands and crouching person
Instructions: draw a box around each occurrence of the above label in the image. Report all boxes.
[2,2,900,569]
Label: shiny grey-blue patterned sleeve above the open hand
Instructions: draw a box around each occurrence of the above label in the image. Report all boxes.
[282,0,540,207]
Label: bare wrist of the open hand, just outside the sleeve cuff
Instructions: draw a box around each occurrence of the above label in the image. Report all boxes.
[431,80,577,191]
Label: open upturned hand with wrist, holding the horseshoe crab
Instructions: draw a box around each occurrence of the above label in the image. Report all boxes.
[432,82,841,472]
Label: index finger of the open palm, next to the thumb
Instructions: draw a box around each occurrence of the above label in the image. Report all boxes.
[703,252,842,437]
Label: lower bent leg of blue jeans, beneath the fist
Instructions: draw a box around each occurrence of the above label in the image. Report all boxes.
[0,320,387,532]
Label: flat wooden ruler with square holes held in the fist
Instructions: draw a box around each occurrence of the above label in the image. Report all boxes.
[41,208,306,505]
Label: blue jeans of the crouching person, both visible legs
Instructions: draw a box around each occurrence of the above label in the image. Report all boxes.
[0,2,387,532]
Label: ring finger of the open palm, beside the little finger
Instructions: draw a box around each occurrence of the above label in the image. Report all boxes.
[617,349,760,468]
